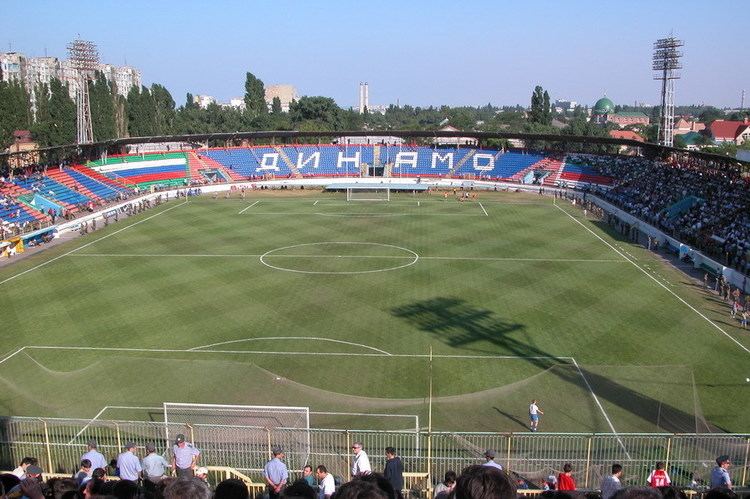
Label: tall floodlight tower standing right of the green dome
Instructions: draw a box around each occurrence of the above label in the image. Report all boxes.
[652,36,684,147]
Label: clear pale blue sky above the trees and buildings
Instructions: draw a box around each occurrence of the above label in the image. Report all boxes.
[0,0,750,107]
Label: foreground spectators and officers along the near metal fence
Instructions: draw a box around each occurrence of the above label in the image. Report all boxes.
[0,440,737,499]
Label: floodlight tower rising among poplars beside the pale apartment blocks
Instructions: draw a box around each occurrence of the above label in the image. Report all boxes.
[68,38,99,144]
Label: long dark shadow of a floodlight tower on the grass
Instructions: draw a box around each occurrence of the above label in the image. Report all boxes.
[391,297,717,433]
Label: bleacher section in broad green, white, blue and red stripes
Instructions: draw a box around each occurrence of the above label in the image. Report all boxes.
[89,153,188,188]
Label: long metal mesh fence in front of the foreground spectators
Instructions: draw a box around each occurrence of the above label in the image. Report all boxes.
[0,417,750,488]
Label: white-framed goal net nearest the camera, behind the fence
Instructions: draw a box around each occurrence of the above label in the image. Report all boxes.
[163,402,310,470]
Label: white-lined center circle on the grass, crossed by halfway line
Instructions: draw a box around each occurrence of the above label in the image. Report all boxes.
[260,241,419,275]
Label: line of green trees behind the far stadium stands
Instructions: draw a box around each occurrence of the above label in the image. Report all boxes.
[0,72,748,152]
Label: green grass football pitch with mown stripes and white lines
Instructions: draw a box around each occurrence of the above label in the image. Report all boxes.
[0,191,750,432]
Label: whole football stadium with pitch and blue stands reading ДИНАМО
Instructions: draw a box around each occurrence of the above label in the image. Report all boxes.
[0,126,750,494]
